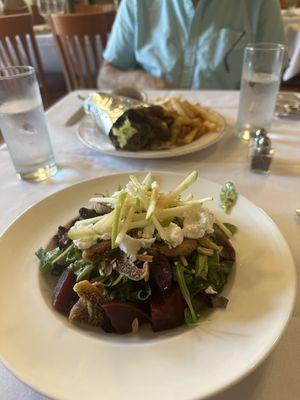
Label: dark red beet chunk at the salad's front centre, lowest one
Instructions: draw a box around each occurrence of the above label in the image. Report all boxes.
[102,300,149,333]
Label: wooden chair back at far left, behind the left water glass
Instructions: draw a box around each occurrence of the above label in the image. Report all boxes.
[0,14,47,92]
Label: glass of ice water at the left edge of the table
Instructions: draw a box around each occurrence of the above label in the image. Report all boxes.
[0,66,57,181]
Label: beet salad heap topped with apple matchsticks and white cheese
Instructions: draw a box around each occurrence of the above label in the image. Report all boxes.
[36,172,237,333]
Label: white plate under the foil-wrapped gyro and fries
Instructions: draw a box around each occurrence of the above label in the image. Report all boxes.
[77,110,226,158]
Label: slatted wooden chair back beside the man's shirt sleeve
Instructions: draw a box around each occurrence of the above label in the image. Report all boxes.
[49,11,115,91]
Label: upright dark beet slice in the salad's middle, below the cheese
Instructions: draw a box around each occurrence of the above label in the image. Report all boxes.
[149,254,172,293]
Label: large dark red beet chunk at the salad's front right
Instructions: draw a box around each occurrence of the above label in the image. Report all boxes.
[151,285,186,332]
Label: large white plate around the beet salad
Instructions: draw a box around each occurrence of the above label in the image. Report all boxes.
[0,173,296,400]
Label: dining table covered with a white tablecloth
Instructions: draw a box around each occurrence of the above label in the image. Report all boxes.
[0,90,300,400]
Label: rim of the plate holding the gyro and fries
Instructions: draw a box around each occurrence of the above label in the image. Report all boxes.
[76,111,228,159]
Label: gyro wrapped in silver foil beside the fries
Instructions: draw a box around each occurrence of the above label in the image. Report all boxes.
[84,92,173,151]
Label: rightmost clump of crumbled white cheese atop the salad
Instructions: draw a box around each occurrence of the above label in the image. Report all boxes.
[183,208,214,239]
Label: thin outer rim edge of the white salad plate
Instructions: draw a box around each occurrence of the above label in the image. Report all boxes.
[0,170,297,400]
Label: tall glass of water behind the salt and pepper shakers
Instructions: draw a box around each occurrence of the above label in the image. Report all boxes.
[236,43,286,140]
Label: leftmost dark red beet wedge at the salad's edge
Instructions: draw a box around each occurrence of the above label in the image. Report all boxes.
[52,268,78,314]
